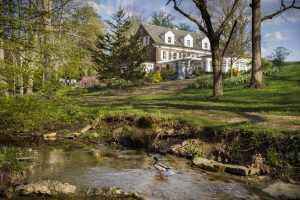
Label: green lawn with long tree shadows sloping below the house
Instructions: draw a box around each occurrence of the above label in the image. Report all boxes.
[83,63,300,130]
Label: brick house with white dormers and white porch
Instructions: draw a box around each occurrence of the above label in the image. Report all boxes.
[138,23,250,77]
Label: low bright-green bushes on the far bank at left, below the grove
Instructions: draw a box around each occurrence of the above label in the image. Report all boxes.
[0,90,92,133]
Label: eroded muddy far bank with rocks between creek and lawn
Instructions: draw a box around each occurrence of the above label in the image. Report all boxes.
[0,116,300,182]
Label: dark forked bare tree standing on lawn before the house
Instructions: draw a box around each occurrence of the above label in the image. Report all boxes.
[167,0,240,98]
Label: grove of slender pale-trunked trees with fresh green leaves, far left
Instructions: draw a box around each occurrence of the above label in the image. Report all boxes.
[0,0,101,94]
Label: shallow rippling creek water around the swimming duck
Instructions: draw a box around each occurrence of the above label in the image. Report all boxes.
[18,145,259,200]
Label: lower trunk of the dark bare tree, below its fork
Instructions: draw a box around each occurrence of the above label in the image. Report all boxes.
[211,42,223,98]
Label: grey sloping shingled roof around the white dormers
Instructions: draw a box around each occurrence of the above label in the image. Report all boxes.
[141,23,206,50]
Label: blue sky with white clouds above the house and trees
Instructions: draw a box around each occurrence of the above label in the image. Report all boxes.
[88,0,300,61]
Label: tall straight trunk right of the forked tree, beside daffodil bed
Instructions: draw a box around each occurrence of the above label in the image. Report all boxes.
[250,0,263,88]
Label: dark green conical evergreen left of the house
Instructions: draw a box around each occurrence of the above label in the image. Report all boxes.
[92,8,147,81]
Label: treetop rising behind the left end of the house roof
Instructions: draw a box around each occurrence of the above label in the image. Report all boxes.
[151,11,174,28]
